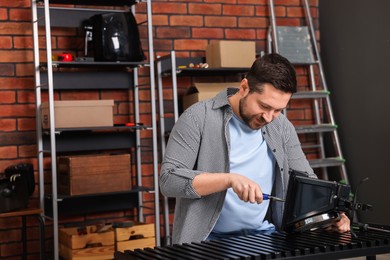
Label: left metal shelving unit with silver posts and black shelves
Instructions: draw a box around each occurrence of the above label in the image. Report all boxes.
[31,0,160,259]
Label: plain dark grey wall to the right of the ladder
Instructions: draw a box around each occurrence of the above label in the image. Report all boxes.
[319,0,390,225]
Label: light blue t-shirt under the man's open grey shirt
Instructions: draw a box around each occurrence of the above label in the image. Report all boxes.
[213,115,275,232]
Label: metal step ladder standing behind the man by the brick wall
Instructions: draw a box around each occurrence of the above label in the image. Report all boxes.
[267,0,348,183]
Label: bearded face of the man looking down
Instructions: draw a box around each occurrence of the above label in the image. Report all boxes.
[239,83,292,130]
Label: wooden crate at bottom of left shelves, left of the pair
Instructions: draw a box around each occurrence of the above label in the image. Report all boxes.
[58,226,115,260]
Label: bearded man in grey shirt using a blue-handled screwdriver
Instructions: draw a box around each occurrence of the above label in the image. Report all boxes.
[160,54,350,244]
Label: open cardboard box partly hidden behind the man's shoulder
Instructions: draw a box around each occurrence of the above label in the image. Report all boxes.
[183,82,240,110]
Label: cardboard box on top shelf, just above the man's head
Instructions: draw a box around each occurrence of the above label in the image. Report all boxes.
[206,41,256,68]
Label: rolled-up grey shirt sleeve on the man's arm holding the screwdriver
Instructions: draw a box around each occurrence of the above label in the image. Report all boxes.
[159,105,203,199]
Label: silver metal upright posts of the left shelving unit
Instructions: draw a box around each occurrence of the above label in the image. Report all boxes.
[31,0,160,259]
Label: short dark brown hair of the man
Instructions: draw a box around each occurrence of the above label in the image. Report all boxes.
[246,53,297,93]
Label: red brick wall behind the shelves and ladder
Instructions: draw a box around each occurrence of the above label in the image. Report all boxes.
[0,0,318,259]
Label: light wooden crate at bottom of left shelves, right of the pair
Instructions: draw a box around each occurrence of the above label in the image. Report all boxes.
[115,223,156,252]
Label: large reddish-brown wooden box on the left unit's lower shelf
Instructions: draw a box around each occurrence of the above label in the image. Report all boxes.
[58,154,131,195]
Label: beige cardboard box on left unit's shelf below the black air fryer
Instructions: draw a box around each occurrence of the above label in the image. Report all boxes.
[41,100,114,129]
